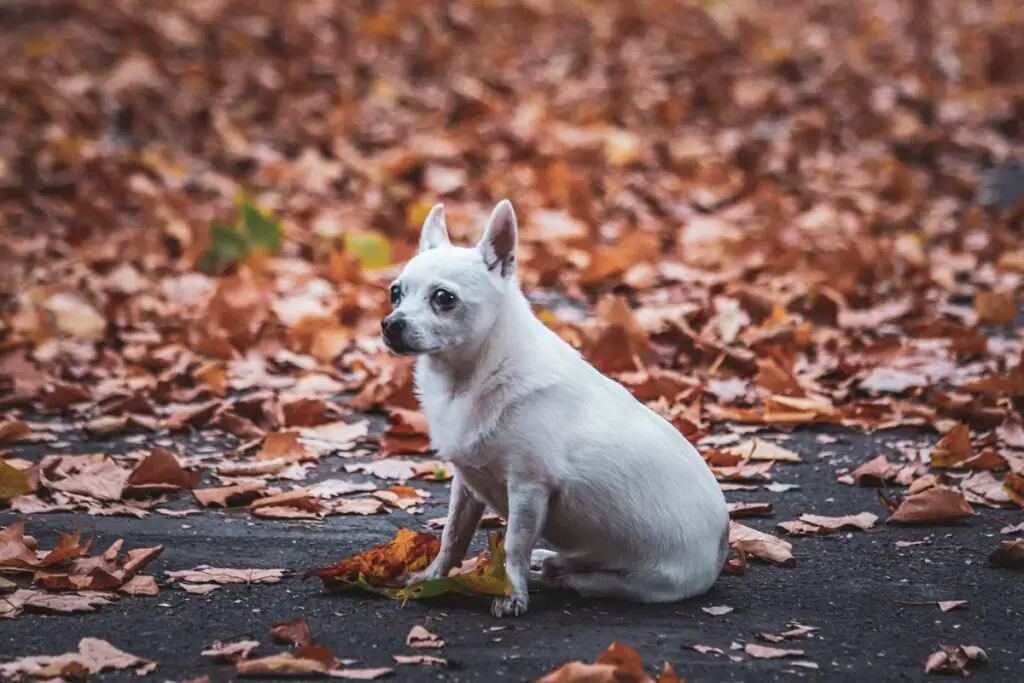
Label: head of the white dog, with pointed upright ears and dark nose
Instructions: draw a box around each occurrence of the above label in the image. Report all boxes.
[381,200,518,355]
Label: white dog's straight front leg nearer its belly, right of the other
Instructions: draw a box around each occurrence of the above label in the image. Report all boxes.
[490,480,551,616]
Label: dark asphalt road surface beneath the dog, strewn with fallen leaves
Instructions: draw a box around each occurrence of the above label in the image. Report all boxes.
[0,423,1024,682]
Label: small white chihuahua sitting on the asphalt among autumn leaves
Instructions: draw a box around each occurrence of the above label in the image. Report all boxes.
[381,200,729,616]
